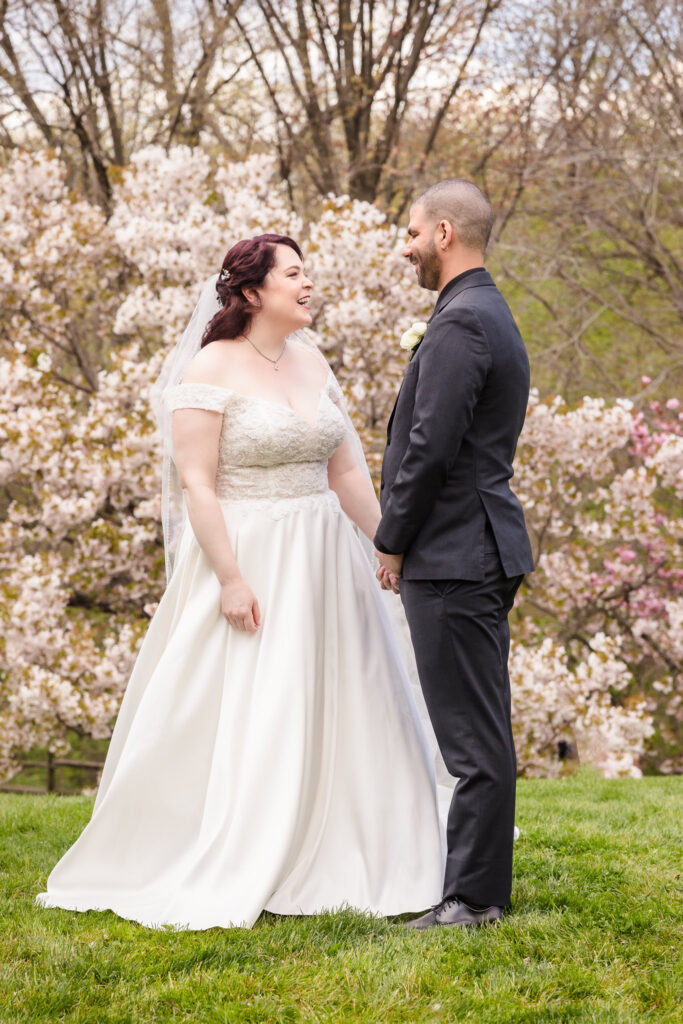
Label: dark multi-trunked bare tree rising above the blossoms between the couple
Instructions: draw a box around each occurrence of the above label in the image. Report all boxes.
[223,0,502,202]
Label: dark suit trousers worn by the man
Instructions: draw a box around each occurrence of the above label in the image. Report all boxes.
[400,550,523,906]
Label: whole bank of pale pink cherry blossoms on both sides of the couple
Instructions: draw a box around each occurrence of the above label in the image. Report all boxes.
[0,147,683,775]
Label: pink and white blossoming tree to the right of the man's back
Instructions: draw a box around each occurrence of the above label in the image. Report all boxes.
[511,394,683,774]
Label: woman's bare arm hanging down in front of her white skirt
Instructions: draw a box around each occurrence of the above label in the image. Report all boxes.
[173,409,260,633]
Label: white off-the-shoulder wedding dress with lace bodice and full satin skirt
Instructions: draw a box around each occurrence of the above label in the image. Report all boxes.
[38,374,443,929]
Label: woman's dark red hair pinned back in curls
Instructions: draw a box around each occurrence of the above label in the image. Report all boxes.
[202,234,303,348]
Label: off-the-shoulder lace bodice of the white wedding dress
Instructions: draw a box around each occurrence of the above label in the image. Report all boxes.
[165,373,346,506]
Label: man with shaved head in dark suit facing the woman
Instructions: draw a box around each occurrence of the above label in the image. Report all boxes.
[375,179,533,929]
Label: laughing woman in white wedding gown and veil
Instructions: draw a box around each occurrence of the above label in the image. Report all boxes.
[38,234,443,929]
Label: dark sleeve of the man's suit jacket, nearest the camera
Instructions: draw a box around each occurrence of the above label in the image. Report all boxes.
[375,308,492,554]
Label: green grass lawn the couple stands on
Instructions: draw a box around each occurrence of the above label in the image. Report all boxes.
[0,773,683,1024]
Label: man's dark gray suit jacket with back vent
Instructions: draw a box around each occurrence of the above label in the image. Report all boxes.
[375,267,533,581]
